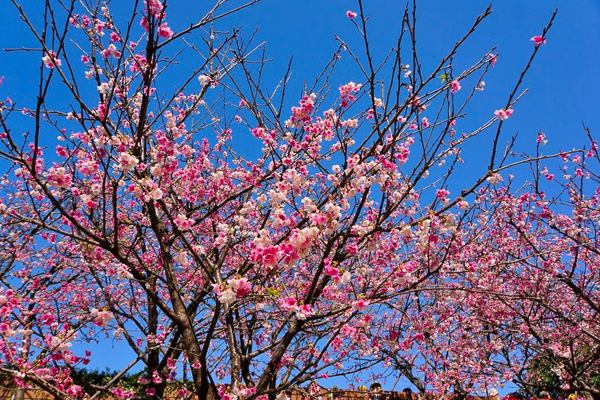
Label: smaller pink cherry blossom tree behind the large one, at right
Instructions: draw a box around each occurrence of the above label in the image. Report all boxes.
[372,133,599,398]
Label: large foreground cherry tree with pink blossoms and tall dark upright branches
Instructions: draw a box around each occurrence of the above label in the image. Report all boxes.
[0,0,598,399]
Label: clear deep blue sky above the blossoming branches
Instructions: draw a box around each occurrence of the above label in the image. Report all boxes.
[0,0,600,394]
